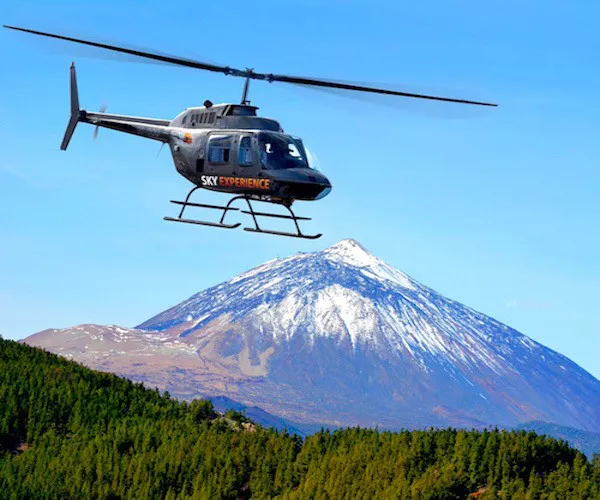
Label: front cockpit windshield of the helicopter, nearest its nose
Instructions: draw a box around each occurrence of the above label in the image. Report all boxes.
[258,132,309,170]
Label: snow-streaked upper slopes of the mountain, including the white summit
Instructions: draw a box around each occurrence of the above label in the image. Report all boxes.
[139,240,539,373]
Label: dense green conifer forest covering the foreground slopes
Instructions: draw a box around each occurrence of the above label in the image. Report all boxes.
[0,339,600,500]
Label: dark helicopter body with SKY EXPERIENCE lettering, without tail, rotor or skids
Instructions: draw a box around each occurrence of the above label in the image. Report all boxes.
[169,104,331,201]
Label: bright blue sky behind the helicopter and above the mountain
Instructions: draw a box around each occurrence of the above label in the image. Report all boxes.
[0,0,600,377]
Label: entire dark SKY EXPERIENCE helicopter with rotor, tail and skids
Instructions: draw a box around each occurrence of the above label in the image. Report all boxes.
[4,25,496,239]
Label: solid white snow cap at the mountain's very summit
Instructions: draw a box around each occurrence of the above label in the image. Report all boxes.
[322,238,415,290]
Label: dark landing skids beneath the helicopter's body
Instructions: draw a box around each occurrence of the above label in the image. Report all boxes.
[164,186,322,240]
